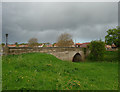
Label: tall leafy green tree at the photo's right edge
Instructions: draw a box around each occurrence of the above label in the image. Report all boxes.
[105,27,120,47]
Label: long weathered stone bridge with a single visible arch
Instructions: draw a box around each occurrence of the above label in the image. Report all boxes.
[3,47,89,62]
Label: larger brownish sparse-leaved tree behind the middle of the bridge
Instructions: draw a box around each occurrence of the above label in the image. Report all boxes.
[57,33,74,47]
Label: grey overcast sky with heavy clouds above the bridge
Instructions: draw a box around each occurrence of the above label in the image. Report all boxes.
[2,2,118,43]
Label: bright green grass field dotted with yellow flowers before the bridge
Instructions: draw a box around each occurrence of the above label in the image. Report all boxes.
[2,52,118,90]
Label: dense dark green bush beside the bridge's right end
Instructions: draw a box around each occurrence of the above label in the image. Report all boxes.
[89,40,105,61]
